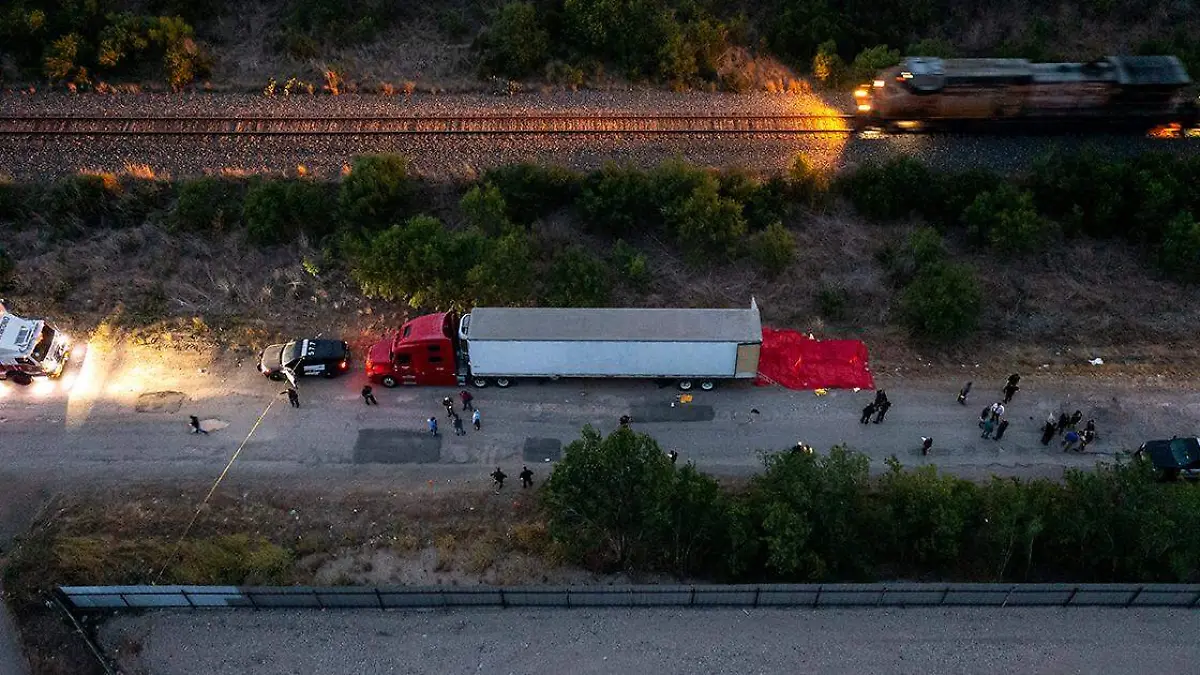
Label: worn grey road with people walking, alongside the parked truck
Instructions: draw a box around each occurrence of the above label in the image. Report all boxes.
[0,341,1200,494]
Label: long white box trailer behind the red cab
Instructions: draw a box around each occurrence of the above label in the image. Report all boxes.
[458,300,762,390]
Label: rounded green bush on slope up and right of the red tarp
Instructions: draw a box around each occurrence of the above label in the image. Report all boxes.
[900,258,983,342]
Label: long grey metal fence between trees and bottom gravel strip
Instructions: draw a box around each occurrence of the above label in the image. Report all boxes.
[59,584,1200,611]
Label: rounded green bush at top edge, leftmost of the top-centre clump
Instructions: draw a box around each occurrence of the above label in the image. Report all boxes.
[481,2,550,78]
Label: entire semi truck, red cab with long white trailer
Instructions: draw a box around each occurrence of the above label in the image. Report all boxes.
[366,299,762,390]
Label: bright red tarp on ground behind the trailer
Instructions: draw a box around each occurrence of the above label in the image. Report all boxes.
[755,328,875,389]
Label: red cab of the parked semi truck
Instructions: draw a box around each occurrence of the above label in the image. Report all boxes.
[367,312,458,388]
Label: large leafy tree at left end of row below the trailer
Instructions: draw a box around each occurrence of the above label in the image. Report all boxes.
[540,425,681,569]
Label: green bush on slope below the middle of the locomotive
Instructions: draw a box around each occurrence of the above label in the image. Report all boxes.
[962,184,1049,255]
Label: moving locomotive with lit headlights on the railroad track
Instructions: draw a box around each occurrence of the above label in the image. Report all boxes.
[854,56,1198,131]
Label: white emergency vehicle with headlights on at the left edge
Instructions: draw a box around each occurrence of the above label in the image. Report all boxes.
[0,303,71,384]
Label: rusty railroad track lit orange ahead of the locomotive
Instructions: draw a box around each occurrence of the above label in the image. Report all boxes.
[0,115,853,136]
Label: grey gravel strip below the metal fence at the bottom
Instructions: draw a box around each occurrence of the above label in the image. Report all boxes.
[101,609,1200,675]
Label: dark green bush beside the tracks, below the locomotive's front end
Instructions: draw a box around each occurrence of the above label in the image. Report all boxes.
[840,157,937,220]
